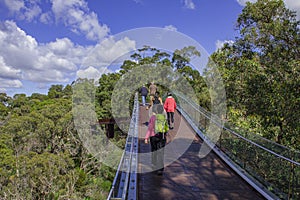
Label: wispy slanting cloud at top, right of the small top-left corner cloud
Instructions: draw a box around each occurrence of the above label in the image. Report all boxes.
[52,0,110,41]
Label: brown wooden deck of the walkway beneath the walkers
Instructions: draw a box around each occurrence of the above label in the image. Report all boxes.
[138,107,264,200]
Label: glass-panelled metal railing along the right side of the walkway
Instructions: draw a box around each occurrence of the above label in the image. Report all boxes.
[175,93,300,199]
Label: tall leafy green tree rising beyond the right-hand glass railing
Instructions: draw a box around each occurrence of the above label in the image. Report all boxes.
[211,0,300,148]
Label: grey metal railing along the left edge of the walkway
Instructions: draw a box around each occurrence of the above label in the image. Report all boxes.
[107,94,139,200]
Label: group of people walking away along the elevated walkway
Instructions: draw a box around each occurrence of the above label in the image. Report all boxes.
[140,82,177,175]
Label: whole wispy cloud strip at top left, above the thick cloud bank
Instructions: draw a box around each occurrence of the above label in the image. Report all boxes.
[4,0,110,41]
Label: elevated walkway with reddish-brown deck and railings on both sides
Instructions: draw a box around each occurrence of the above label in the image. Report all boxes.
[107,95,300,200]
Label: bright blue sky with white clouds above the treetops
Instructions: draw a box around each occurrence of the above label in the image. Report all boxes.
[0,0,300,96]
